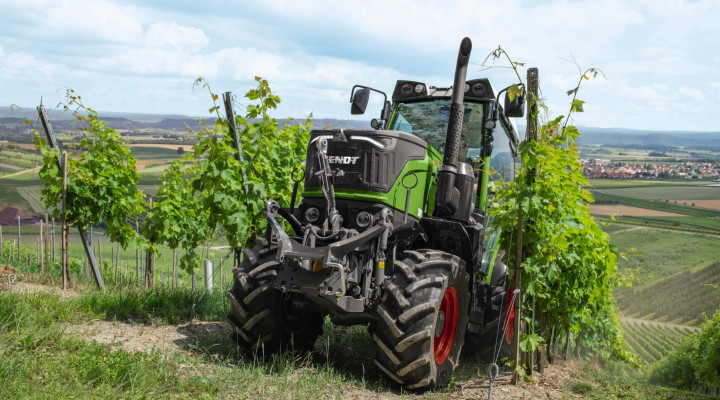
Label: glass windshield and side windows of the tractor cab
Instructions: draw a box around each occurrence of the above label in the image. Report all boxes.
[389,99,515,182]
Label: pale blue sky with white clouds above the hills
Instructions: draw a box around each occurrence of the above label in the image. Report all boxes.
[0,0,720,132]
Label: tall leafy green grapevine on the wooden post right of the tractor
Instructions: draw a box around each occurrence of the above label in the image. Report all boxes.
[490,58,627,359]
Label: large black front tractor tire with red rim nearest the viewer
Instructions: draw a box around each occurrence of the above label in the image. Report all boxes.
[373,250,470,389]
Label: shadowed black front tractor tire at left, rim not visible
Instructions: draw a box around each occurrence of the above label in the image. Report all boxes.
[227,240,323,354]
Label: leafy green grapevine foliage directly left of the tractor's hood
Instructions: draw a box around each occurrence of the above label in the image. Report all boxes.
[149,77,311,271]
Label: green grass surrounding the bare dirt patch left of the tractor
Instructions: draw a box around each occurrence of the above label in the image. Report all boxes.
[0,282,420,398]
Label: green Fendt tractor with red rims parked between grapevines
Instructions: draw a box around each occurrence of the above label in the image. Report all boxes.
[227,38,524,389]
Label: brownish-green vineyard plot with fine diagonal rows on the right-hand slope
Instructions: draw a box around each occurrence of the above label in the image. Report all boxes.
[615,262,720,325]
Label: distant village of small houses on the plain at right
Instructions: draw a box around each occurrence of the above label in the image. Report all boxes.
[579,158,720,181]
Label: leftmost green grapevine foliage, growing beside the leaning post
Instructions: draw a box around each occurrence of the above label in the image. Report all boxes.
[33,89,145,248]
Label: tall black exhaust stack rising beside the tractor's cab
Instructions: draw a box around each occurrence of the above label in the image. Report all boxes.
[435,38,472,218]
